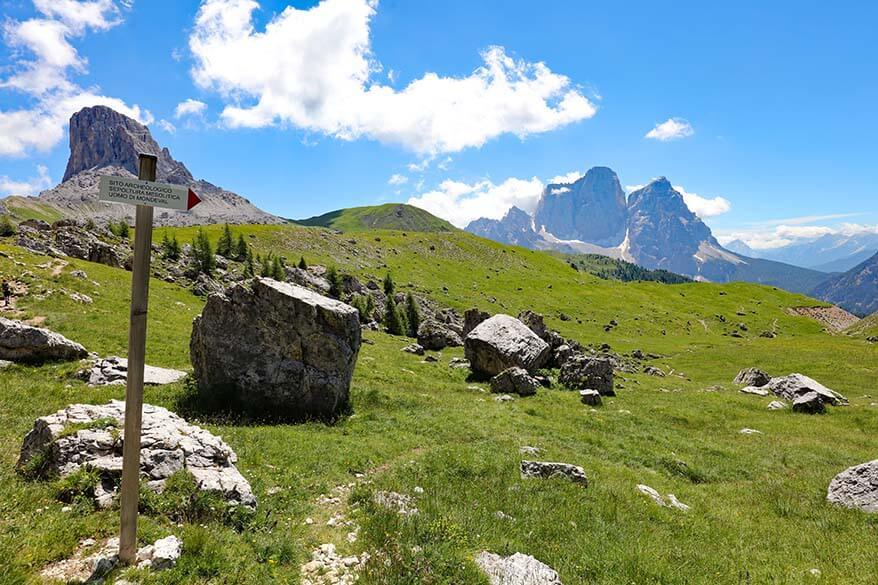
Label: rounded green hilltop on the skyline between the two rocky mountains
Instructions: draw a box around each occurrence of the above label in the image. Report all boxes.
[296,203,457,232]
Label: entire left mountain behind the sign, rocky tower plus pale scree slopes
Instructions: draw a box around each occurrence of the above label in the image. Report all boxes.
[31,106,284,226]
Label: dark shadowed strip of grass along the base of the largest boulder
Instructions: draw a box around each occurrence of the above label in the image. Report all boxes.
[174,376,353,426]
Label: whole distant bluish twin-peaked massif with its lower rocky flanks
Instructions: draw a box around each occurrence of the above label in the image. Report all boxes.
[465,167,827,292]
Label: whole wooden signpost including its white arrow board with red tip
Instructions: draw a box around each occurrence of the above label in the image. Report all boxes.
[99,154,201,565]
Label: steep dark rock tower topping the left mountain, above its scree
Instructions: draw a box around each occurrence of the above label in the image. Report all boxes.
[63,106,194,185]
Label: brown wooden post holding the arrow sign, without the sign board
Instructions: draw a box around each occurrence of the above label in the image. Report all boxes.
[119,154,158,565]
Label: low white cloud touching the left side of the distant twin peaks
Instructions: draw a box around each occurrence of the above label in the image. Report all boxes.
[408,177,543,227]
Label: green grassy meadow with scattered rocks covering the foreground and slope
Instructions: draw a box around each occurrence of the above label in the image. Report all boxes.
[0,226,878,584]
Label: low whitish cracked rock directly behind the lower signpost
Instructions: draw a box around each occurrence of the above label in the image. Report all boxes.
[17,400,256,508]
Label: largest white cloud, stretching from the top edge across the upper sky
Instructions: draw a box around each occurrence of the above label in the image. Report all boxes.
[189,0,596,154]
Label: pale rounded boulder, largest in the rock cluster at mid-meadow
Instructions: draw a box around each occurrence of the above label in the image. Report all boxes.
[464,315,550,376]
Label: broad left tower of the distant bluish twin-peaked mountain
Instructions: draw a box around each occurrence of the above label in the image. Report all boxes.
[534,167,628,246]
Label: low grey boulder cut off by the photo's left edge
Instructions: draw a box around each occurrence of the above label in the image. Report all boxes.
[0,317,88,362]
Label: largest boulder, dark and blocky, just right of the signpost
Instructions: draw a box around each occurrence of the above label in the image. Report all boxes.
[189,278,360,418]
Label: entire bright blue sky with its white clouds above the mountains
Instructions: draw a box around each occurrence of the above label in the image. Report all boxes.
[0,0,878,246]
